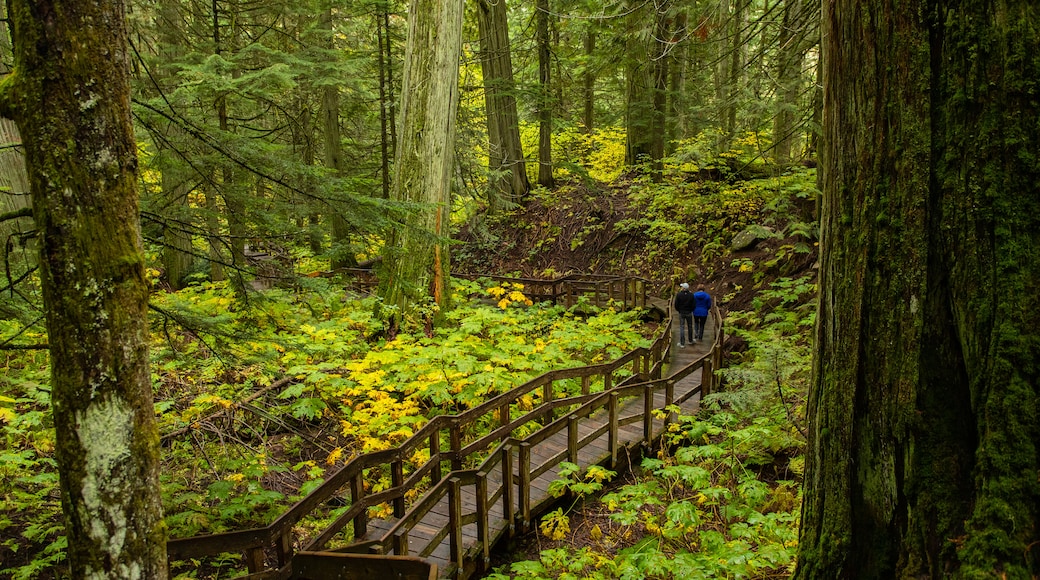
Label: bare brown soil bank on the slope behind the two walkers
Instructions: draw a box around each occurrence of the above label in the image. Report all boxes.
[452,181,816,318]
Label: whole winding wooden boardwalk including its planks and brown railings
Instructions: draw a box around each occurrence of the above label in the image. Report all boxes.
[166,275,725,580]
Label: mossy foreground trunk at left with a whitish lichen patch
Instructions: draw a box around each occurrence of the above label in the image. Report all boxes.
[0,0,168,579]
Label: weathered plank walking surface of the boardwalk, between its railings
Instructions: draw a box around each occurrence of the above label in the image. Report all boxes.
[345,307,716,578]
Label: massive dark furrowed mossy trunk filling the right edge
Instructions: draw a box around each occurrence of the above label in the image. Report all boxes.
[796,0,1040,579]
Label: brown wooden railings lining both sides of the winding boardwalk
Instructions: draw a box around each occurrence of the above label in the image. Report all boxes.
[167,276,723,578]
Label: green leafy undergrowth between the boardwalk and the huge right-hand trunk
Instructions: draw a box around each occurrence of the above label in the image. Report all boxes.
[491,278,815,580]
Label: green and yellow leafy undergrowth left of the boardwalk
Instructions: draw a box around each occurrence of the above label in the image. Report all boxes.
[0,280,648,578]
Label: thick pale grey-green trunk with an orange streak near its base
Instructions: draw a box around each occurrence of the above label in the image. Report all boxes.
[380,0,463,322]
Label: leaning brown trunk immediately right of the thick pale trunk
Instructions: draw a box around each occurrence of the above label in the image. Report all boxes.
[477,0,530,209]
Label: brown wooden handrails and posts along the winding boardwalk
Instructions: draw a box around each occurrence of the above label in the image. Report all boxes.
[167,276,722,576]
